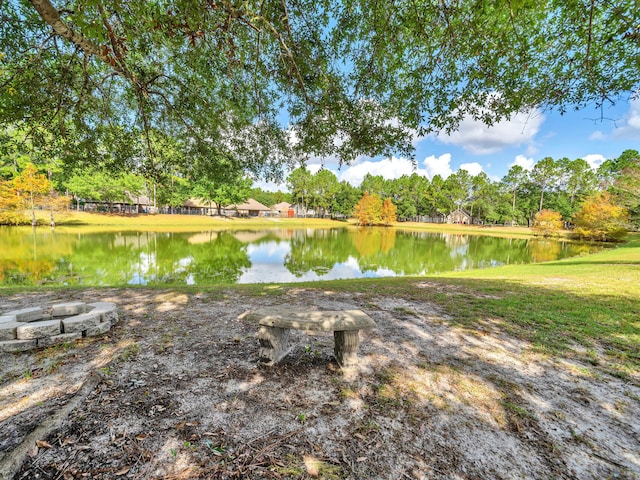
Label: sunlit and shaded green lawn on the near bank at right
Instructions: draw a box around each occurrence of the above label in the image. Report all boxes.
[284,235,640,378]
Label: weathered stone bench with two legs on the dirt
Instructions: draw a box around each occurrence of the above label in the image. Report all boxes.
[246,307,376,367]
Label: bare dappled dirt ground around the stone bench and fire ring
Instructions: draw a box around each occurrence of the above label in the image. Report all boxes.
[0,282,640,480]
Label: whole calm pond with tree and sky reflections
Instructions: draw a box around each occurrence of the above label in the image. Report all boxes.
[0,227,599,286]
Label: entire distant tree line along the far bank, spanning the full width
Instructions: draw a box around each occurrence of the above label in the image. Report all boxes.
[0,142,640,237]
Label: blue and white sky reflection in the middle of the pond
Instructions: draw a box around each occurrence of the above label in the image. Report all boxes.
[238,241,396,283]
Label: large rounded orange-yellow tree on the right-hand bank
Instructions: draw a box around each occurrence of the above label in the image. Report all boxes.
[573,192,629,242]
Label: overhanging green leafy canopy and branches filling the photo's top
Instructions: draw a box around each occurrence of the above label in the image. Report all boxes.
[0,0,640,178]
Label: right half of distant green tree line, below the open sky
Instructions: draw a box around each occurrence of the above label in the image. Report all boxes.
[287,150,640,227]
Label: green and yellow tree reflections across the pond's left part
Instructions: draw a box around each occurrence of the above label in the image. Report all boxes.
[0,232,251,285]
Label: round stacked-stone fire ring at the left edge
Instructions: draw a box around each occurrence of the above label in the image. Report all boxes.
[0,302,118,353]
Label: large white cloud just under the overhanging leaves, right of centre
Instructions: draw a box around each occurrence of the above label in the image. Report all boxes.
[437,109,545,155]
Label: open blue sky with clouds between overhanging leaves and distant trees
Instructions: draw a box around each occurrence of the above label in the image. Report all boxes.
[255,99,640,191]
